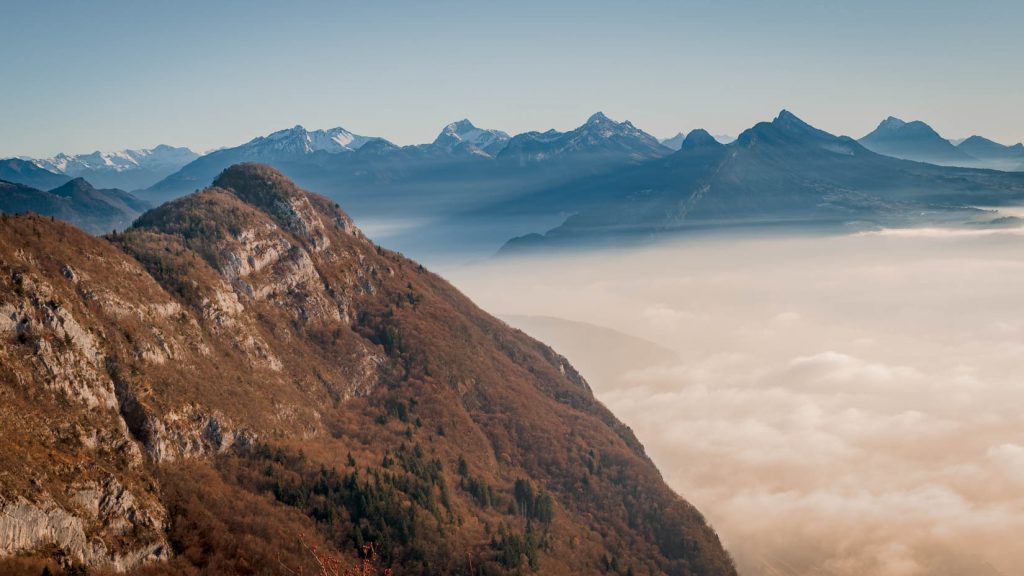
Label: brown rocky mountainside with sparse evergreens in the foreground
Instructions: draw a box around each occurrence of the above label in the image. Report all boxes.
[0,165,735,575]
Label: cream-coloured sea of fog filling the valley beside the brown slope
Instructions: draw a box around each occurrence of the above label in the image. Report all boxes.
[442,231,1024,576]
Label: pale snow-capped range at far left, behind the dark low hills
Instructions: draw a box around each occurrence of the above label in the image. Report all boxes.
[23,145,199,190]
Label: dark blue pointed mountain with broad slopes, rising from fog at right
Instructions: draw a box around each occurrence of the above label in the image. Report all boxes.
[505,111,1024,251]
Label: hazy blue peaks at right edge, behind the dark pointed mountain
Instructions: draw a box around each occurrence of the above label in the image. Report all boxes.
[859,116,1024,171]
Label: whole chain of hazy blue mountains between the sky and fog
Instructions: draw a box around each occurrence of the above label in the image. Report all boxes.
[6,113,1024,261]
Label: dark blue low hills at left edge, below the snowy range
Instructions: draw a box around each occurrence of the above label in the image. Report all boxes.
[0,178,148,234]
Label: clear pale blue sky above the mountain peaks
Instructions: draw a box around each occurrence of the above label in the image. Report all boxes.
[0,0,1024,157]
